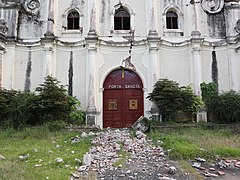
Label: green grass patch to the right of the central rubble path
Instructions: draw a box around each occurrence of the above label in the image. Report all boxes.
[149,126,240,160]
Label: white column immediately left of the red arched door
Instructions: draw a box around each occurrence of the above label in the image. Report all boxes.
[86,33,98,125]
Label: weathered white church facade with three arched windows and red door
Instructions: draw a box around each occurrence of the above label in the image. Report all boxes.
[0,0,240,127]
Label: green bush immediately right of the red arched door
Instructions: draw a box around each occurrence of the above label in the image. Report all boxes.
[147,79,203,121]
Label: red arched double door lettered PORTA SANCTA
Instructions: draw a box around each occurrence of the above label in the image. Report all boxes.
[103,69,144,128]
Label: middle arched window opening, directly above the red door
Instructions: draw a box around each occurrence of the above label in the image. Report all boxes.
[114,7,130,30]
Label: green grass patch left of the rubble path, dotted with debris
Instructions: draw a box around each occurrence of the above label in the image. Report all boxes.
[0,127,93,180]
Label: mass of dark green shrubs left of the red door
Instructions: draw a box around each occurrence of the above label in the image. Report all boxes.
[0,76,85,130]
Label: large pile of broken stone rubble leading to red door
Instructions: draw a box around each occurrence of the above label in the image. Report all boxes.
[72,129,188,180]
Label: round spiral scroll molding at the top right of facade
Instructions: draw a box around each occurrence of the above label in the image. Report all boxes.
[201,0,224,14]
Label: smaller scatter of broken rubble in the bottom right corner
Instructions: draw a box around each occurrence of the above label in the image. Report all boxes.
[192,158,240,178]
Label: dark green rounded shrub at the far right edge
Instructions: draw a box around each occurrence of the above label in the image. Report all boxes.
[208,90,240,123]
